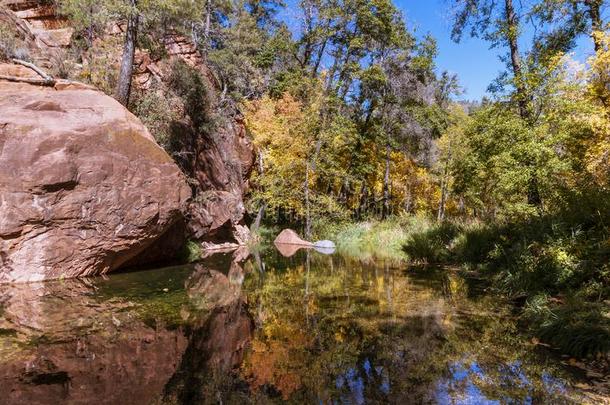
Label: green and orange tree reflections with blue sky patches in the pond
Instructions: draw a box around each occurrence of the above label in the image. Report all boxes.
[236,254,580,403]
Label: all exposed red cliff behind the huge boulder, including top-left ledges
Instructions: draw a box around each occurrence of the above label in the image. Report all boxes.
[0,0,254,256]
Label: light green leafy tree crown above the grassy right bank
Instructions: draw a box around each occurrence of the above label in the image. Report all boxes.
[453,105,569,218]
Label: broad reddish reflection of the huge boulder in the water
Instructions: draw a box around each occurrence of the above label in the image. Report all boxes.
[0,280,187,404]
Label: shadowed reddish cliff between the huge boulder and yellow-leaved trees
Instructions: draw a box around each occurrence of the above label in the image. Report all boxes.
[136,47,254,248]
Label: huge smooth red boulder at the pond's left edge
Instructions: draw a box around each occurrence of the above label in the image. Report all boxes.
[0,65,190,282]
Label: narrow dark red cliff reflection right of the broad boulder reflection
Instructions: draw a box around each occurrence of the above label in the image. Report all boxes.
[163,262,254,404]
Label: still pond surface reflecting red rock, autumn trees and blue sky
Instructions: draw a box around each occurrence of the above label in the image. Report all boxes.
[0,245,608,404]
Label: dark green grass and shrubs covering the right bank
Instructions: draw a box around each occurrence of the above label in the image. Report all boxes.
[404,196,610,356]
